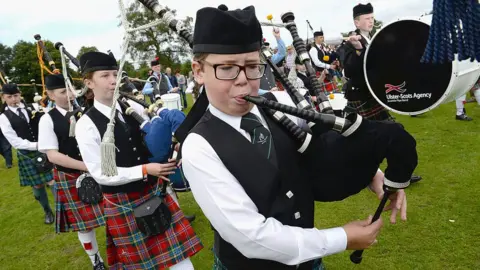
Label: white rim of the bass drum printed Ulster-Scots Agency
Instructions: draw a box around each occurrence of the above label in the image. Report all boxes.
[363,15,458,115]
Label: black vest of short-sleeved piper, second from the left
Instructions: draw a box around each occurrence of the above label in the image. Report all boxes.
[48,109,82,173]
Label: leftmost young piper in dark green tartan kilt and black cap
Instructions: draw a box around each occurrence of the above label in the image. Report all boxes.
[0,84,55,224]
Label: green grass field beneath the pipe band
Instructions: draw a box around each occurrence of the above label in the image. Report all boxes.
[0,94,480,270]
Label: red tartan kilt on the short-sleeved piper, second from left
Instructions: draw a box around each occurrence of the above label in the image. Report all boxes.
[53,169,105,233]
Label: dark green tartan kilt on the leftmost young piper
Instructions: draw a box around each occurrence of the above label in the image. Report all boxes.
[17,150,53,187]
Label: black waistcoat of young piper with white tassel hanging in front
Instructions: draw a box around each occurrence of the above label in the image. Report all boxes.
[86,107,150,193]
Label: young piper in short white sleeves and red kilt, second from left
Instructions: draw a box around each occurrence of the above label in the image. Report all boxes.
[38,74,105,270]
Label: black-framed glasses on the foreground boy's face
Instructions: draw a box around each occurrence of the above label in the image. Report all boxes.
[202,60,267,81]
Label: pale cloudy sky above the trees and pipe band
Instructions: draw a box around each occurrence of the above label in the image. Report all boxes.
[0,0,433,66]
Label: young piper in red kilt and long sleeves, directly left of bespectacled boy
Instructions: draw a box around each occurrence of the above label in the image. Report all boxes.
[75,52,203,269]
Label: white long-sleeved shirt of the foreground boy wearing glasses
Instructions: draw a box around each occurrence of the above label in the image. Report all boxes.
[182,106,347,265]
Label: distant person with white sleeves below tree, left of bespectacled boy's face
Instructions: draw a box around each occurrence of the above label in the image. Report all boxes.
[142,57,178,102]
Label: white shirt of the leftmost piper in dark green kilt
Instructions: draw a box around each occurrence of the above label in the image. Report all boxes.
[0,106,37,151]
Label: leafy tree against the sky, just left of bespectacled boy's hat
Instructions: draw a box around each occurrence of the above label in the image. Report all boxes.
[121,1,193,68]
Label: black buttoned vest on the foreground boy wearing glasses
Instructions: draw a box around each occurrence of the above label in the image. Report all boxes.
[191,109,314,270]
